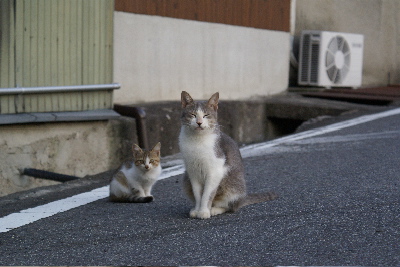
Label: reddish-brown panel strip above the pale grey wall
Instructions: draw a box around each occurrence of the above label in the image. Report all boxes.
[115,0,290,32]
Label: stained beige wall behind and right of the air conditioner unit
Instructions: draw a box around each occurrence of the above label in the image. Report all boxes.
[292,0,400,86]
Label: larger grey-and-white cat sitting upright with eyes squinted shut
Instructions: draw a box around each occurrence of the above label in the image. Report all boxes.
[179,91,277,219]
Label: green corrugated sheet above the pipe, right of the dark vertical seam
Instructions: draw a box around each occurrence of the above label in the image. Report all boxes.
[12,0,113,87]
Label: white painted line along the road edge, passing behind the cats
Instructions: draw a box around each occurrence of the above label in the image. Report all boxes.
[0,108,400,233]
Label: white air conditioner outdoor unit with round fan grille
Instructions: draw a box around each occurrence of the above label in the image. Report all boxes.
[298,30,364,88]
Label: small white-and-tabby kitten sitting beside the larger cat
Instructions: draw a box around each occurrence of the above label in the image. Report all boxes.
[110,142,161,203]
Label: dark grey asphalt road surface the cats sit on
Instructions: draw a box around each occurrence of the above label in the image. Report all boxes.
[0,107,400,266]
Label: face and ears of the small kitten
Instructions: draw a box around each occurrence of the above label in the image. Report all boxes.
[133,143,161,171]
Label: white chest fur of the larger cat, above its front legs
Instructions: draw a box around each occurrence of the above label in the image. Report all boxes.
[179,128,227,184]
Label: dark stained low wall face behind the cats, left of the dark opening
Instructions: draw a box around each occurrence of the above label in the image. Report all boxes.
[133,101,268,156]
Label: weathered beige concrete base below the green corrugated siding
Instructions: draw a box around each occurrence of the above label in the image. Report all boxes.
[0,117,137,196]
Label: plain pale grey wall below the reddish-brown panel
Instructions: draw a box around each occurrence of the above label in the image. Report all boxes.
[114,12,290,104]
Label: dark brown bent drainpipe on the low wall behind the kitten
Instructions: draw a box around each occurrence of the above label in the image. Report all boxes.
[114,104,149,149]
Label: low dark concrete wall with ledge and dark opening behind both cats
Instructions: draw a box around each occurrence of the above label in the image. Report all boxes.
[133,93,374,156]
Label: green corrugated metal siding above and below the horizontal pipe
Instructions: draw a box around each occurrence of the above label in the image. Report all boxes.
[0,0,114,114]
